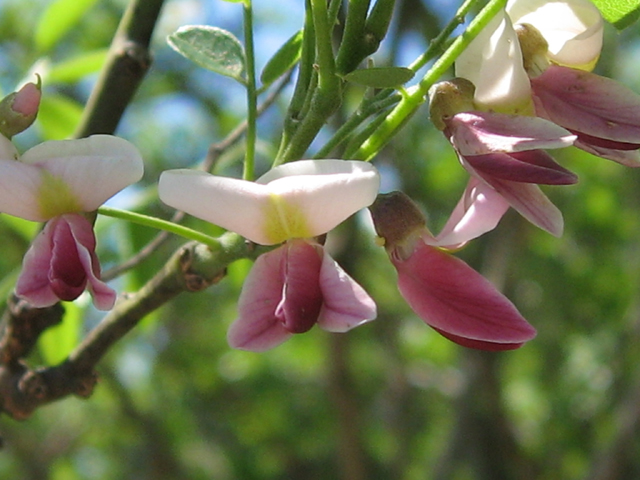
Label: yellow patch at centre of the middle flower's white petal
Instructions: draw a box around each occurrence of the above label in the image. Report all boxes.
[264,194,313,244]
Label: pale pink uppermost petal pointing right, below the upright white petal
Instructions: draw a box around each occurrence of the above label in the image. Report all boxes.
[446,112,576,156]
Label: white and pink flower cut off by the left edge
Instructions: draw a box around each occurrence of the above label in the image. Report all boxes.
[0,135,143,310]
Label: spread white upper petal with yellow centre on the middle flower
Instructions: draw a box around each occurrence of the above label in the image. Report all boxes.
[158,160,380,245]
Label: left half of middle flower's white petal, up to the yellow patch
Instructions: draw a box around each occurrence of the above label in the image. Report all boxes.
[158,169,278,245]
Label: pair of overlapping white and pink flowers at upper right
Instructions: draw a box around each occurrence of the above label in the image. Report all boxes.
[430,0,640,236]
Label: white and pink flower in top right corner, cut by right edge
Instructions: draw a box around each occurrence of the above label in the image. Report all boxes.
[508,0,640,167]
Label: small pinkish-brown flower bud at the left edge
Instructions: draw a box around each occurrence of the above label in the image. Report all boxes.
[0,77,42,138]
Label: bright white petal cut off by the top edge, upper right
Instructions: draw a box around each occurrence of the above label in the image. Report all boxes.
[507,0,604,70]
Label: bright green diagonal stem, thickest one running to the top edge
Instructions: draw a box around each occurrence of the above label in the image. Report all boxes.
[351,0,506,161]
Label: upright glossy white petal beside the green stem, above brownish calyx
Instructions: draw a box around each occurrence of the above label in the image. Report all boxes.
[455,12,531,113]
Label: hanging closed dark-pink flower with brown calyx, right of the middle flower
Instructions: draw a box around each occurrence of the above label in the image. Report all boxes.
[369,192,535,351]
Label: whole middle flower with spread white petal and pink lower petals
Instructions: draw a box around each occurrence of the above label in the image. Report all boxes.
[158,160,379,351]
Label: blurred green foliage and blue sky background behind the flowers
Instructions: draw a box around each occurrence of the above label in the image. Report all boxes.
[0,0,640,480]
